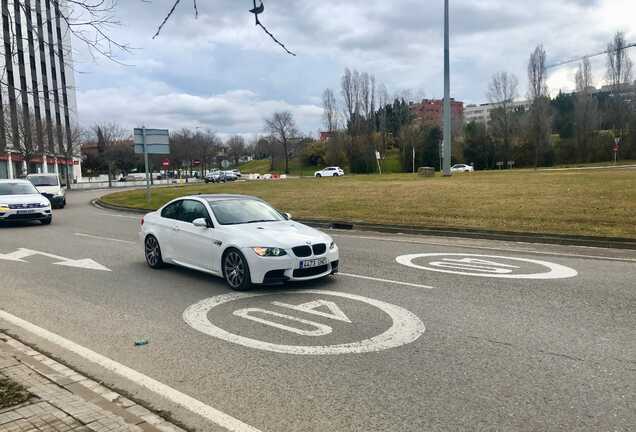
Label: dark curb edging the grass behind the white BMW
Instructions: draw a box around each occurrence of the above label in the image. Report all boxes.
[91,198,636,250]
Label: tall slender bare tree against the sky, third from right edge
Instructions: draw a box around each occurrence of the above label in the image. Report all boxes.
[528,45,550,168]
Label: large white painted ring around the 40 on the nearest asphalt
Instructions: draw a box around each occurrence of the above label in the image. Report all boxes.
[183,290,426,355]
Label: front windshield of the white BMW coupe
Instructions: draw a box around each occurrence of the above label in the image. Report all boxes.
[208,199,285,225]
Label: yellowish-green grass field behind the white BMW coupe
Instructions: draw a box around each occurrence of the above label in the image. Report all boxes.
[103,169,636,238]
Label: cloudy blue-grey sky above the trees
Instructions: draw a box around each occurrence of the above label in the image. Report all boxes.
[74,0,636,136]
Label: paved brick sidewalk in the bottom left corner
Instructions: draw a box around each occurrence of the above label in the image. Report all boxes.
[0,332,184,432]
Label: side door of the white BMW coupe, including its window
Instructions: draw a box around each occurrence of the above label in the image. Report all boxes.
[175,199,219,271]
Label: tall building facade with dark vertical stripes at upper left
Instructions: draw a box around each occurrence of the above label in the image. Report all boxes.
[0,0,81,181]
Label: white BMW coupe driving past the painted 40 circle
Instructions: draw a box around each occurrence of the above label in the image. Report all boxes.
[140,195,339,291]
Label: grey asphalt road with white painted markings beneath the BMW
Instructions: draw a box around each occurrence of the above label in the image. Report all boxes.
[0,192,636,432]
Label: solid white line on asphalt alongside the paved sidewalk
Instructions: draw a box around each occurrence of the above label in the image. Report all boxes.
[0,310,261,432]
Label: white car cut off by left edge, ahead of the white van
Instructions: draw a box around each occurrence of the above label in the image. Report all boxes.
[0,180,53,225]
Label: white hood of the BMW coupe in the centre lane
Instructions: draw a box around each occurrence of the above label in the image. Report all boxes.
[226,221,332,249]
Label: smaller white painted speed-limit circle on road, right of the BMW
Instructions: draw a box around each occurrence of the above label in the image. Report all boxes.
[395,253,578,279]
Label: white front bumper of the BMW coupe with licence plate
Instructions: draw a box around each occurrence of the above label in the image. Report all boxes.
[242,246,340,285]
